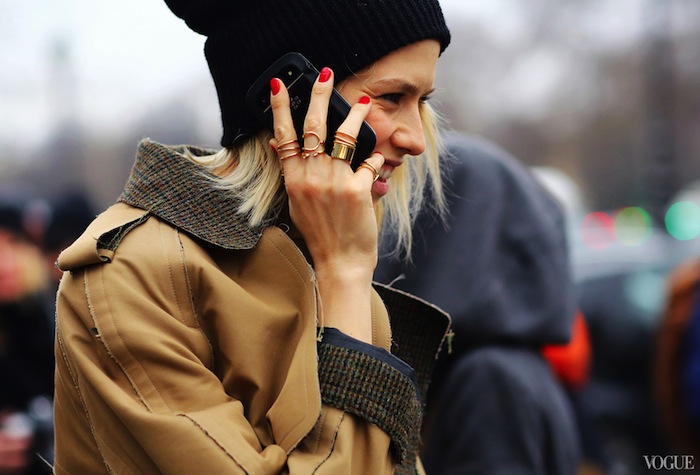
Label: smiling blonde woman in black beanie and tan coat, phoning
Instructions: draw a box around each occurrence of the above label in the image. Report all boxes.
[55,0,449,474]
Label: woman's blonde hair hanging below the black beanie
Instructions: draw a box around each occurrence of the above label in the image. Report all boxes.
[189,103,446,257]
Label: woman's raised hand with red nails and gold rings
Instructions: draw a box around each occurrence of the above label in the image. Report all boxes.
[270,68,384,341]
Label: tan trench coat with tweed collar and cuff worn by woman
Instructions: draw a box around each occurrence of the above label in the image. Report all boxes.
[55,142,449,475]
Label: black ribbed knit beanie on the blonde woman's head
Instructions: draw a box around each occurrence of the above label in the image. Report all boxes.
[165,0,450,147]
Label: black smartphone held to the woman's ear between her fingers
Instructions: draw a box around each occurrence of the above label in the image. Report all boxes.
[246,53,377,170]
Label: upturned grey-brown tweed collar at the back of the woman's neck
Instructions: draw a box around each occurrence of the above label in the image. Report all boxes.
[119,139,270,249]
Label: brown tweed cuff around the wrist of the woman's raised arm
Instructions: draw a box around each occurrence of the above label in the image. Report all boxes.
[318,328,423,464]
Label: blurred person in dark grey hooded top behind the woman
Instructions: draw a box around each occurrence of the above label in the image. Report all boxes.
[375,134,589,475]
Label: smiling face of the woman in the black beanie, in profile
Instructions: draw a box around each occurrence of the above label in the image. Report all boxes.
[339,40,440,198]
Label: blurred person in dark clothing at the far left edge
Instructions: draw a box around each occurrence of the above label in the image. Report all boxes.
[0,199,54,475]
